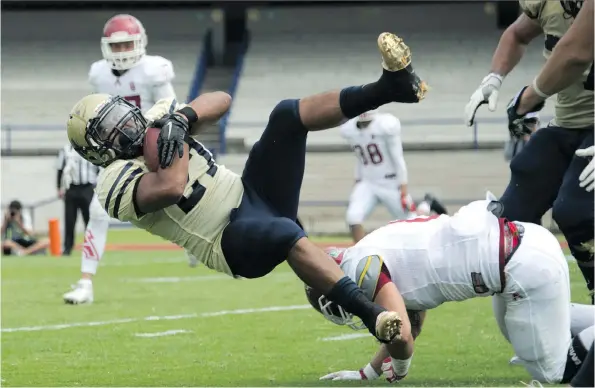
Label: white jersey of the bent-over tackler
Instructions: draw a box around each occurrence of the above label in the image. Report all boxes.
[341,201,501,310]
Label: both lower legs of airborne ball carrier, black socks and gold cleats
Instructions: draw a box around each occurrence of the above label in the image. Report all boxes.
[288,33,427,341]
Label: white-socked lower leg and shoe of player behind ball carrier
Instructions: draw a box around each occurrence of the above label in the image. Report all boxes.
[63,196,109,304]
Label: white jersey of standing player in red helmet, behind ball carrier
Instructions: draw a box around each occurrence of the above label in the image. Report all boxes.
[89,55,175,112]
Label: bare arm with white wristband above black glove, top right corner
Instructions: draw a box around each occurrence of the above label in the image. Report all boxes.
[519,0,595,107]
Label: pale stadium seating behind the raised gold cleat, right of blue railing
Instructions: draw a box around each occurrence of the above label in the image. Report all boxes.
[227,3,551,143]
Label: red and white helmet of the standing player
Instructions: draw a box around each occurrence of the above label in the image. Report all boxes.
[101,14,147,70]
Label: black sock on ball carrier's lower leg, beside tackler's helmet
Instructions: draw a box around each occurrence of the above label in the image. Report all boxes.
[326,276,384,336]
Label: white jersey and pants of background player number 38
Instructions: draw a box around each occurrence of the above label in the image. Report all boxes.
[340,112,408,225]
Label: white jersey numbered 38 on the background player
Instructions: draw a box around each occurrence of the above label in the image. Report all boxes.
[340,113,407,184]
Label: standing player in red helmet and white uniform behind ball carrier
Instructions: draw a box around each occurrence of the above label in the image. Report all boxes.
[63,15,197,304]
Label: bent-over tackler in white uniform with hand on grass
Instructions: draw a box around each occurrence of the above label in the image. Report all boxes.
[306,200,593,383]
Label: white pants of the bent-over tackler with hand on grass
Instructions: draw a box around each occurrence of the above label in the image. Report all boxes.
[493,223,571,384]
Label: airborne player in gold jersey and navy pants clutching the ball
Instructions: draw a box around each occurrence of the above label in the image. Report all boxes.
[67,33,427,342]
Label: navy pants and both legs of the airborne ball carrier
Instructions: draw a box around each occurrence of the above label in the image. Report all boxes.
[229,33,427,341]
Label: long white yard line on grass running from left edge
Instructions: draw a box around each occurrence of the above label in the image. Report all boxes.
[2,304,312,333]
